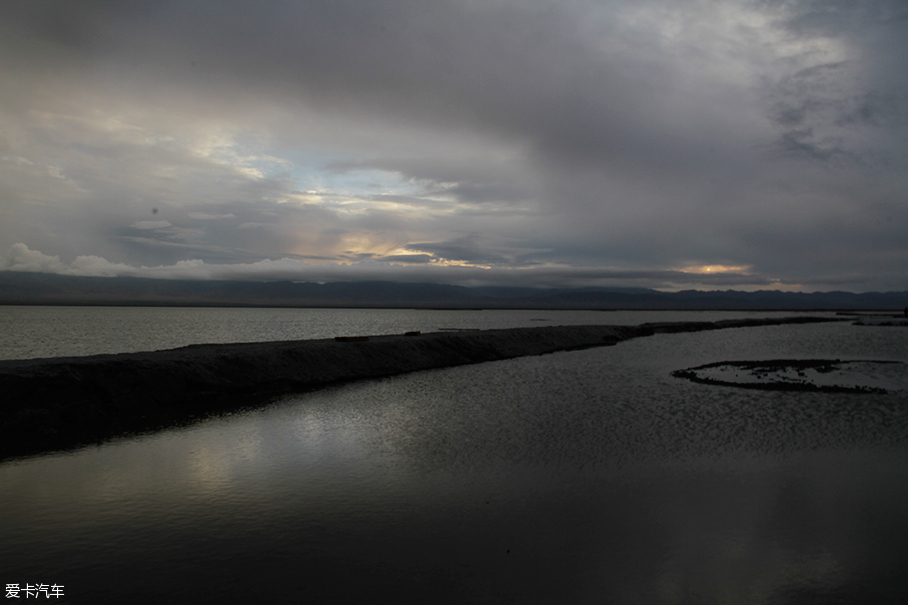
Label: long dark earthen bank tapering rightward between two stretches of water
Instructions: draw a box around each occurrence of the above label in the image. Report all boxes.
[0,317,836,459]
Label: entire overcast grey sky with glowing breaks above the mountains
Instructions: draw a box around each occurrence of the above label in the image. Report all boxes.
[0,0,908,292]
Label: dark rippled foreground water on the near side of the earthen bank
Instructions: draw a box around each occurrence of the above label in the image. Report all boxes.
[0,314,908,604]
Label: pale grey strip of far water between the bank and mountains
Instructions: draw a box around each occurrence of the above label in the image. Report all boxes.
[0,305,829,359]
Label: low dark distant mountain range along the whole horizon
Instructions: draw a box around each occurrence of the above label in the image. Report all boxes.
[0,271,908,311]
